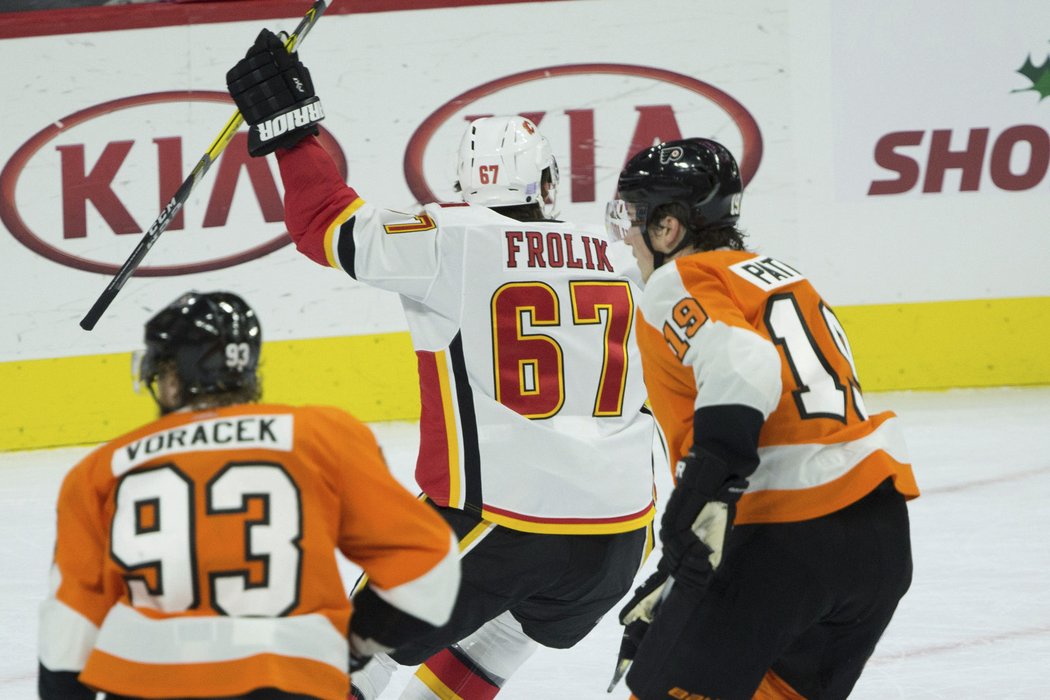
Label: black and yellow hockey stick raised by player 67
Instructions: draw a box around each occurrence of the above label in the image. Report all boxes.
[80,0,328,331]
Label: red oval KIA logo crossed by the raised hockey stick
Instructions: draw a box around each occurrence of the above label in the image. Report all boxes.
[0,91,347,277]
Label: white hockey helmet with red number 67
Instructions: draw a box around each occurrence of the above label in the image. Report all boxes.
[456,115,559,207]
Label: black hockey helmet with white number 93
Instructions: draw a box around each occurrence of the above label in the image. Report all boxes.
[139,292,263,405]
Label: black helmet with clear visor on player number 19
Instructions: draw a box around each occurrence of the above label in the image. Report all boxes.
[617,139,743,248]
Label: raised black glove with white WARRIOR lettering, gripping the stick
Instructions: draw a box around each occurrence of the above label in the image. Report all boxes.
[226,29,324,156]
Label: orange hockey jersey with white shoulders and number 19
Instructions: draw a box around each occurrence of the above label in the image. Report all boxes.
[638,250,919,524]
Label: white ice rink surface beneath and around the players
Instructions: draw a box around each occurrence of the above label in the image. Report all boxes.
[0,387,1050,700]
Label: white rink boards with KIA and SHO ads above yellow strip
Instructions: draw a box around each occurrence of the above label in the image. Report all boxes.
[0,0,1050,361]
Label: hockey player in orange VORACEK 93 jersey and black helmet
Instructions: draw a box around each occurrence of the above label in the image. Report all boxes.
[39,292,460,700]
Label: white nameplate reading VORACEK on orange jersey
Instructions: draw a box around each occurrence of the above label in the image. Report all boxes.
[110,416,293,476]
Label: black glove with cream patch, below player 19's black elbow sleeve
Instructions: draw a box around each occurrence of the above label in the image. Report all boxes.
[657,447,748,589]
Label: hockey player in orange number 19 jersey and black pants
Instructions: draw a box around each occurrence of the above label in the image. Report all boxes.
[608,139,919,700]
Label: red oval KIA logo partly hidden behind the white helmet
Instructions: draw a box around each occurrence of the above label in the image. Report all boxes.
[403,63,762,206]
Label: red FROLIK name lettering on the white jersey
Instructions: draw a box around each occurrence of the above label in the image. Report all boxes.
[503,231,615,272]
